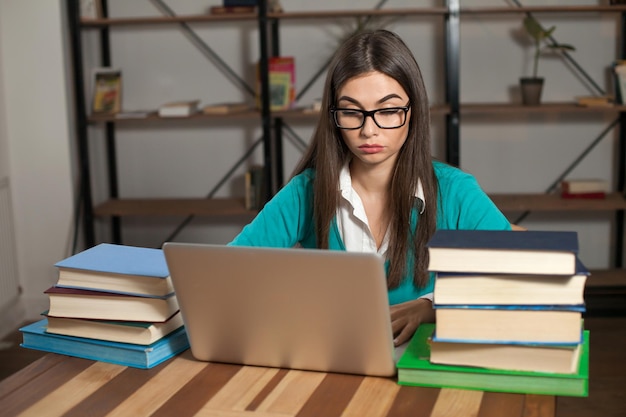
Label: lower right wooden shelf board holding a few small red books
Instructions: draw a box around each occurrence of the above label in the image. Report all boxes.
[489,193,626,211]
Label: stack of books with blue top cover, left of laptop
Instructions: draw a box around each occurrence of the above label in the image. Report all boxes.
[20,243,189,368]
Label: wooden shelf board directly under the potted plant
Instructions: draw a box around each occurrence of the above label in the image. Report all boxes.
[460,102,626,116]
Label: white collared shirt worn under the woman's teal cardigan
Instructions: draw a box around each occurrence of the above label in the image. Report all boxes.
[337,162,433,302]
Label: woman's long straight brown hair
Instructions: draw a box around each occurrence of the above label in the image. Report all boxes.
[295,30,438,288]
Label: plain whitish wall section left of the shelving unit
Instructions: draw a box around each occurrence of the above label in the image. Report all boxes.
[0,0,73,330]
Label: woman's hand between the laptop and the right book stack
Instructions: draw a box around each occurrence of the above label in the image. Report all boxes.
[390,298,435,346]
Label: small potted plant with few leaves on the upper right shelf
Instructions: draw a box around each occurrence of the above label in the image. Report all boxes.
[520,15,575,105]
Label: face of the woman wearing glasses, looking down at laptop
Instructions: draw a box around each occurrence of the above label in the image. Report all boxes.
[335,71,411,171]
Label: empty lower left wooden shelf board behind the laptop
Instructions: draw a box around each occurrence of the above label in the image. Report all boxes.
[94,198,256,217]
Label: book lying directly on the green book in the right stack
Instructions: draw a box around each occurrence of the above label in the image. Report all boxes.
[429,339,582,374]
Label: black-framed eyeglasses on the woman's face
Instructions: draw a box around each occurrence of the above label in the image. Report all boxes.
[330,104,411,130]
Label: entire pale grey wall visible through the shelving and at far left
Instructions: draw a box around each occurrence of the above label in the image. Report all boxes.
[0,0,618,328]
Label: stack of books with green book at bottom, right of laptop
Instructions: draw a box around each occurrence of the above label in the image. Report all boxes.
[398,230,589,396]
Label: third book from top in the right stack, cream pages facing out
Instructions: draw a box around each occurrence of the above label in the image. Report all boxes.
[433,303,585,345]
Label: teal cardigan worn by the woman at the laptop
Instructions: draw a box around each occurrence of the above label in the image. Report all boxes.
[230,161,511,305]
